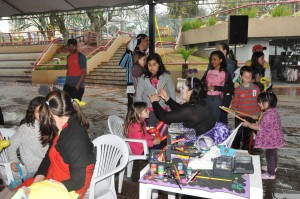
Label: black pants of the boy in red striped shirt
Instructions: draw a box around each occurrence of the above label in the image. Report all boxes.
[231,117,255,150]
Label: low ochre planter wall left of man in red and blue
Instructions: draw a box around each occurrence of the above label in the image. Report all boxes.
[32,70,67,84]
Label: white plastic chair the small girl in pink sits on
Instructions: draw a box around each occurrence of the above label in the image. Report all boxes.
[107,115,149,193]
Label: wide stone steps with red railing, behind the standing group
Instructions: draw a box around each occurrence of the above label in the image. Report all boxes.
[85,45,127,87]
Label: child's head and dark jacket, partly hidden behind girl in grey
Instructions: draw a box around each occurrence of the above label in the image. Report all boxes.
[132,51,147,96]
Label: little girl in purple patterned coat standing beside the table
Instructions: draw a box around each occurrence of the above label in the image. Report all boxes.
[243,91,284,180]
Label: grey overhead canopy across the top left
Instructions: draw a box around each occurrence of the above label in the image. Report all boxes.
[0,0,188,17]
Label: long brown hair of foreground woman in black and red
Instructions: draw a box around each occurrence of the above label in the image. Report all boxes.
[40,90,89,144]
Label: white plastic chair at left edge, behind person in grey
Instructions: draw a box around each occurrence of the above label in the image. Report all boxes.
[0,128,15,185]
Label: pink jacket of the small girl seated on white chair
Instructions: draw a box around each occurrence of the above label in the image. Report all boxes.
[128,122,153,155]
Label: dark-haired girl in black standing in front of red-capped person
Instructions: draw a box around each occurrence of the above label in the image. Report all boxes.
[250,52,266,91]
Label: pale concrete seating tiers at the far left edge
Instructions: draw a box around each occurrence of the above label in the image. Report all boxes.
[0,52,41,83]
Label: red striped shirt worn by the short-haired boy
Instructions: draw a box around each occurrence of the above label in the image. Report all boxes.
[231,83,260,116]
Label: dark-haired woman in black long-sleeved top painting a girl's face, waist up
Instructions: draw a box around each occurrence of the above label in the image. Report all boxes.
[149,77,216,136]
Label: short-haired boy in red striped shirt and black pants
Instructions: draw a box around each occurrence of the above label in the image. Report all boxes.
[231,66,260,151]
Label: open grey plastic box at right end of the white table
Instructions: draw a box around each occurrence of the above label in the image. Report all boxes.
[233,156,254,174]
